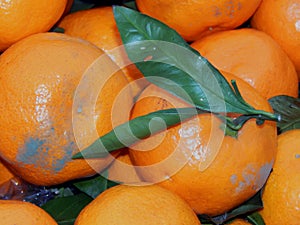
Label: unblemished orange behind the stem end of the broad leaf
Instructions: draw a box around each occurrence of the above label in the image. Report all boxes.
[191,28,298,99]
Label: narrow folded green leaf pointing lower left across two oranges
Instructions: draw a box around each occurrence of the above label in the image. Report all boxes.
[73,108,202,159]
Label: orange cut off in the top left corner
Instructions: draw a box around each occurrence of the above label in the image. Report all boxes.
[0,0,67,51]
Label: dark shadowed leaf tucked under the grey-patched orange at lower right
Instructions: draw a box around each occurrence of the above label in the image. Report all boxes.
[198,189,263,224]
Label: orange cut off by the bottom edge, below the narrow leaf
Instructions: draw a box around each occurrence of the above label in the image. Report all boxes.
[75,185,200,225]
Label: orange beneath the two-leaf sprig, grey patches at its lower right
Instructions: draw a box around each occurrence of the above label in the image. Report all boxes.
[130,73,277,216]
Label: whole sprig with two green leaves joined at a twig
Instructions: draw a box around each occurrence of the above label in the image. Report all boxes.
[73,6,278,159]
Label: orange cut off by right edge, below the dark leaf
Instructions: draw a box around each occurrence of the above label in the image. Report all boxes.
[260,129,300,225]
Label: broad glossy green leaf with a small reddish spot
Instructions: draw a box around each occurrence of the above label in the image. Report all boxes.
[113,6,264,114]
